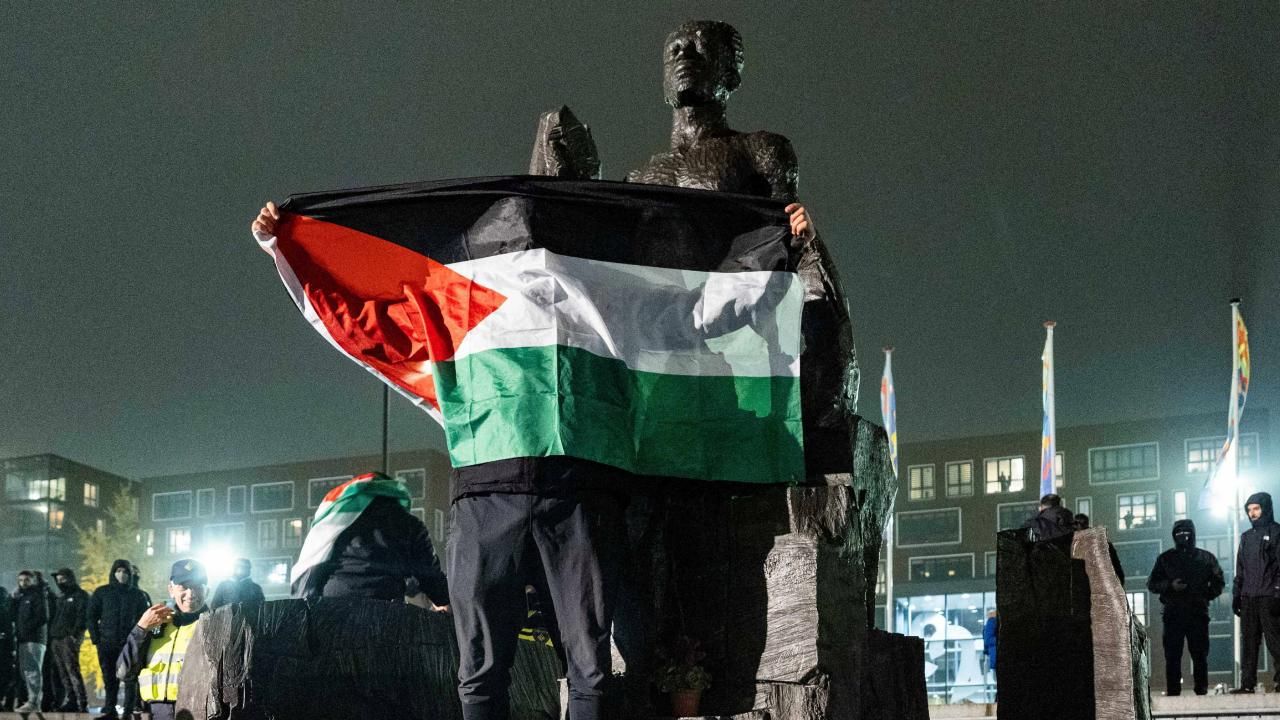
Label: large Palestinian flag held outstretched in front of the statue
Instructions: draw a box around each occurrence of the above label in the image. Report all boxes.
[257,177,804,483]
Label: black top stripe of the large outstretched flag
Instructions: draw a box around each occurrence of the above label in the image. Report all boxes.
[282,177,794,272]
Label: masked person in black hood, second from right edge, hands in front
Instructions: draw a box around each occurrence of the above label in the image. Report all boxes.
[1147,520,1226,696]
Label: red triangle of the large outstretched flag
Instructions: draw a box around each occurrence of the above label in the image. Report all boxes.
[276,213,506,407]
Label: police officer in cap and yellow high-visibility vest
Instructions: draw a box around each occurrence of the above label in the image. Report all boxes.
[115,560,209,720]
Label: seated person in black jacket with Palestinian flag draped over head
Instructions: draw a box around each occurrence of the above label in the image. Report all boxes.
[292,473,449,602]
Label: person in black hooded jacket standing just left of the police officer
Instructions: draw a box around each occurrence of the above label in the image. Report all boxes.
[88,560,147,720]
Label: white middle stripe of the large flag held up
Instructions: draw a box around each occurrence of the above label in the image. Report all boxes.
[449,249,804,377]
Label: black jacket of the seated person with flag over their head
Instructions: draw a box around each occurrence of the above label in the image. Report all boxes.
[316,497,449,605]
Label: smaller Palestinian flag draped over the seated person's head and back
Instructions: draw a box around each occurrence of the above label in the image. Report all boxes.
[289,473,412,597]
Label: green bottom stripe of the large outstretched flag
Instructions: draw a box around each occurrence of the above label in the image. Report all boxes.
[435,346,804,483]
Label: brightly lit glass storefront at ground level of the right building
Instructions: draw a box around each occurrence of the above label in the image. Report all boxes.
[893,592,996,705]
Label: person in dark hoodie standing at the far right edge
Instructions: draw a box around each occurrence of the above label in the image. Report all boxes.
[1231,492,1280,693]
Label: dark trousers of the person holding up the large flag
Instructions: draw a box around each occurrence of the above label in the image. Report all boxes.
[448,493,625,720]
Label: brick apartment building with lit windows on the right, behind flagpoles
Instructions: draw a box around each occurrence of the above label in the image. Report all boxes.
[877,407,1280,703]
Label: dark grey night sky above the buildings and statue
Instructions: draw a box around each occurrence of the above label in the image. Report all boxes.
[0,0,1280,477]
